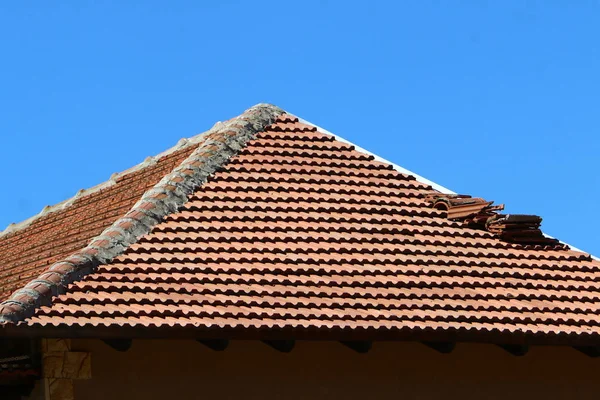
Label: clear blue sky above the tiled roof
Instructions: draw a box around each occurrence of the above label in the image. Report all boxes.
[0,0,600,255]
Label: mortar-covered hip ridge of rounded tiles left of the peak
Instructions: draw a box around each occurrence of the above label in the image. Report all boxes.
[0,103,285,324]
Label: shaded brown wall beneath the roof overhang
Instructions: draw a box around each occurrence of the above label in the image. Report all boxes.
[42,340,600,400]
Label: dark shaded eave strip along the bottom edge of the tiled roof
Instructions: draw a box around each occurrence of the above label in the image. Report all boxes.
[0,321,598,347]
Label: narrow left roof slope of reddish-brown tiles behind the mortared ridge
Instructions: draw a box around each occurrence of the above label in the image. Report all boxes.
[0,146,194,301]
